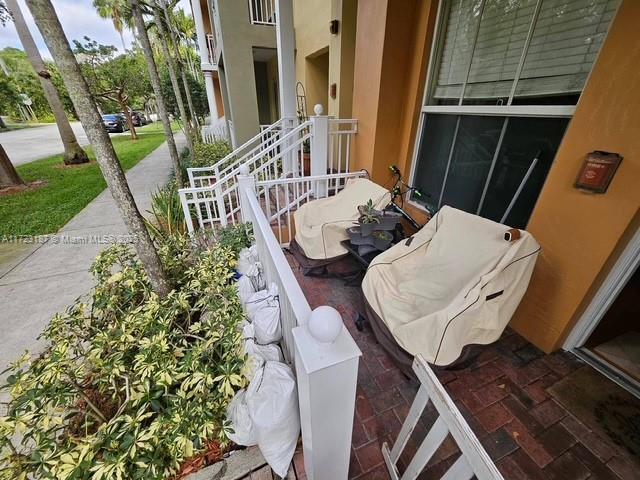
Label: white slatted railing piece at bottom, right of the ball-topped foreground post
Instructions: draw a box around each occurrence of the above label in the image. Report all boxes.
[382,355,504,480]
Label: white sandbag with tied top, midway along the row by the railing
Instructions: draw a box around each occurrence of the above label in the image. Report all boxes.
[245,283,282,345]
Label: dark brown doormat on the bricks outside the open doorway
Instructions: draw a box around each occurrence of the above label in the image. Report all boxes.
[548,367,640,467]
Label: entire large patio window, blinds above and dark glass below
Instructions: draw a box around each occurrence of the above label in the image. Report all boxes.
[413,0,619,228]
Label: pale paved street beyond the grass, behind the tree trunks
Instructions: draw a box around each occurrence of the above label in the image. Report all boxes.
[0,122,129,166]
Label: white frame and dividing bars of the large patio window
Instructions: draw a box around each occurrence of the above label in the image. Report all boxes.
[404,0,622,220]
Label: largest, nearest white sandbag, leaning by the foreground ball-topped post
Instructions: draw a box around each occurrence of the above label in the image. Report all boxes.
[245,362,300,477]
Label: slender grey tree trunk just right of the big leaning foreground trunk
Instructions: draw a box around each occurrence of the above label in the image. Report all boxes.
[129,0,182,187]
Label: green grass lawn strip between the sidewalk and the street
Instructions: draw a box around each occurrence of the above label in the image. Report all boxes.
[0,122,172,237]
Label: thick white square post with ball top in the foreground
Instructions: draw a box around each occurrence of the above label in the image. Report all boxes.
[293,306,362,480]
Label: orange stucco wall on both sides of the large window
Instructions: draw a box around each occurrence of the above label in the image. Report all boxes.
[353,0,640,351]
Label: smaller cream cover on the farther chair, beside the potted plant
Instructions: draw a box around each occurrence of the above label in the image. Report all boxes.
[293,178,391,260]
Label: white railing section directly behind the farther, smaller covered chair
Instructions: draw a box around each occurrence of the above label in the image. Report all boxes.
[256,170,367,247]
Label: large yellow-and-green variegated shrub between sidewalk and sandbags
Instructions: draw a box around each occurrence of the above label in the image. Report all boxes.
[0,227,248,480]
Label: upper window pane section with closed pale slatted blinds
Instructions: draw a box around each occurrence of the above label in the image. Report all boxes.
[428,0,619,105]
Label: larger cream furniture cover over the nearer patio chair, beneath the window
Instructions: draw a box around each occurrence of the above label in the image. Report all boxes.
[362,206,540,365]
